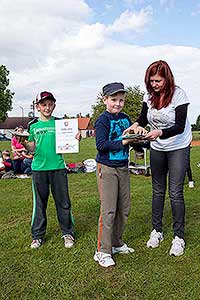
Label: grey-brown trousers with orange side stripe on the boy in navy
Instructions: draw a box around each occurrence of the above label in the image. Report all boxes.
[97,163,130,254]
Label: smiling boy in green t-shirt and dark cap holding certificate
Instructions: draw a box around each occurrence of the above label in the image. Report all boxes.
[22,91,77,249]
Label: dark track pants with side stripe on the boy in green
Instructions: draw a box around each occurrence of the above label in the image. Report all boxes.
[31,169,74,239]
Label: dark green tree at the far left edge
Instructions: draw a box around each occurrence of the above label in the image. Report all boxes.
[0,65,14,122]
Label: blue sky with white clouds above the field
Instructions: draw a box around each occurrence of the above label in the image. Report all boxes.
[0,0,200,124]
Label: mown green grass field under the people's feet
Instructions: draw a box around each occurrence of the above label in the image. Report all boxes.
[0,138,200,300]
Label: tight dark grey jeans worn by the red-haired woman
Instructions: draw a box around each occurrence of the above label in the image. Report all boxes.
[150,146,190,238]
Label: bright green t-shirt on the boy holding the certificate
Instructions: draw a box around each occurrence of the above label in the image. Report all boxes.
[28,117,65,171]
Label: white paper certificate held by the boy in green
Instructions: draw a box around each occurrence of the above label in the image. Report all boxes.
[55,119,79,153]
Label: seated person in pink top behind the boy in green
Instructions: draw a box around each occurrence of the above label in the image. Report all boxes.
[11,125,25,174]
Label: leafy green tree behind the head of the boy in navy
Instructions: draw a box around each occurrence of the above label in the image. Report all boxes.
[92,86,144,123]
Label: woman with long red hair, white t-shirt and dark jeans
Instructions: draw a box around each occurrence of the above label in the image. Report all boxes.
[126,60,192,256]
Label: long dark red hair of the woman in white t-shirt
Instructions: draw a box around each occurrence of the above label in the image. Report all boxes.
[144,60,175,109]
